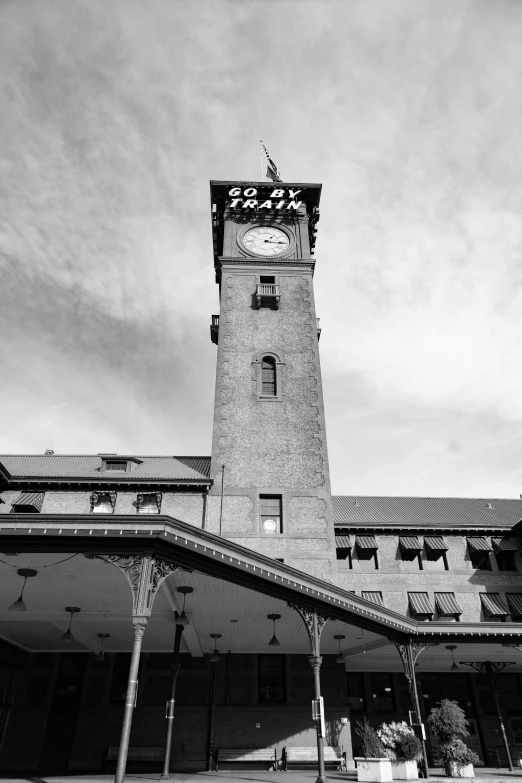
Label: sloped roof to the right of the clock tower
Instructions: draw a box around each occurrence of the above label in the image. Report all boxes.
[332,496,522,529]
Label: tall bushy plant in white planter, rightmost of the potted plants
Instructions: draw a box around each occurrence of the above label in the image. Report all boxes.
[429,699,479,778]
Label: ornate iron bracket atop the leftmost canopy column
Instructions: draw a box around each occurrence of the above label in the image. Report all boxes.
[85,554,180,617]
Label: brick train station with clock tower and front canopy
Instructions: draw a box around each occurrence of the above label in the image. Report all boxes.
[0,182,522,780]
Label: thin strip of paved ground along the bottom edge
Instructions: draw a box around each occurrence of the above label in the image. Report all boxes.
[0,767,522,783]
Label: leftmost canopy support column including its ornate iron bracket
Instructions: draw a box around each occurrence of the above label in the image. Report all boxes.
[85,553,179,783]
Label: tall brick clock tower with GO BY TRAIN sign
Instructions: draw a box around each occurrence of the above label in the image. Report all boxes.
[207,181,336,579]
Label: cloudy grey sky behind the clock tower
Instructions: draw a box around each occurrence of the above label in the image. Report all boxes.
[0,0,522,498]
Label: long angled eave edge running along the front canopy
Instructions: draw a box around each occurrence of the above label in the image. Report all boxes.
[0,514,522,642]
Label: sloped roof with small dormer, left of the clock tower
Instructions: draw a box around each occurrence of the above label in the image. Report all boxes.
[0,454,210,483]
